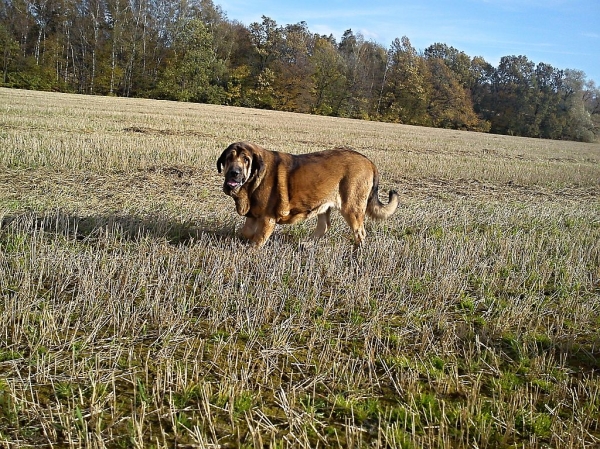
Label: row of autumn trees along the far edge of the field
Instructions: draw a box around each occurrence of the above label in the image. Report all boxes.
[0,0,600,141]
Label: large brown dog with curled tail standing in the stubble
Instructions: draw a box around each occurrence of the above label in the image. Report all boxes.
[217,142,399,246]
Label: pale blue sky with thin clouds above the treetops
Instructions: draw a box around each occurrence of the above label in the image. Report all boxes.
[218,0,600,86]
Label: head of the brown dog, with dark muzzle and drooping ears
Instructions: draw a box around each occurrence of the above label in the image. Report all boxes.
[217,142,264,195]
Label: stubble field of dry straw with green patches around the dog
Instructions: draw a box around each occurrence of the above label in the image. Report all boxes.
[0,89,600,448]
